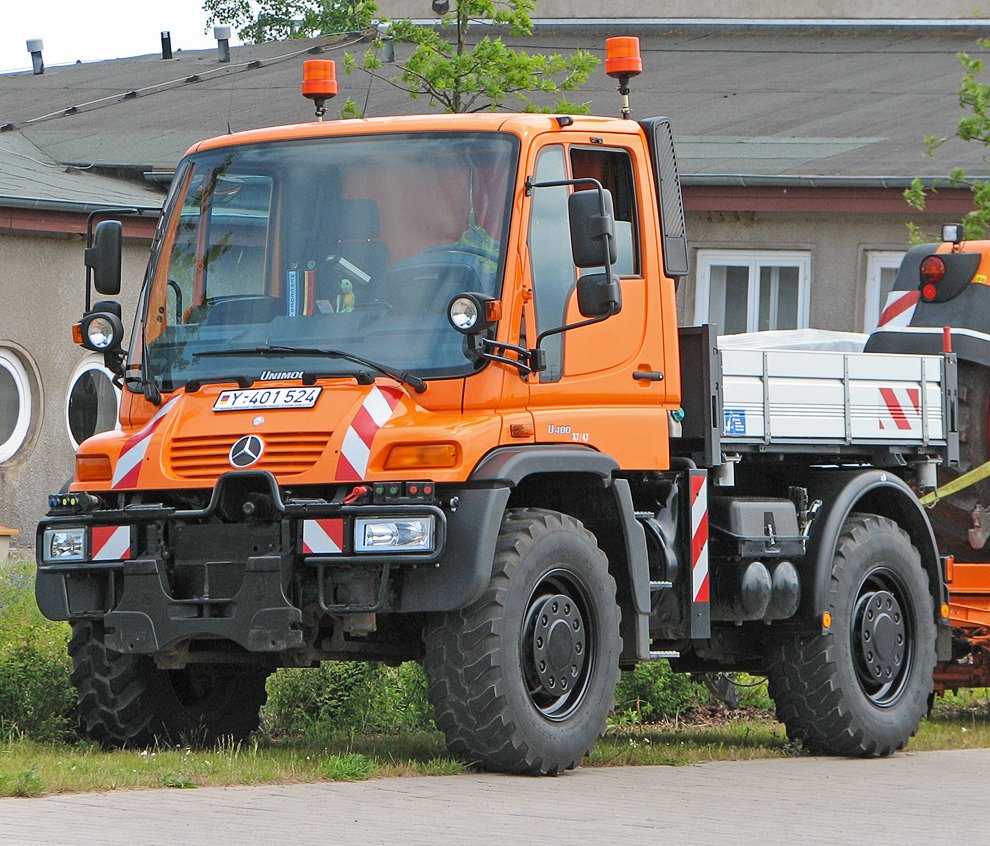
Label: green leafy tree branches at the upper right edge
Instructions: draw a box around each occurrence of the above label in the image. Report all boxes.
[904,46,990,243]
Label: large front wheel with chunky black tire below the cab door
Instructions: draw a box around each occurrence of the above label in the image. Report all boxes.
[424,509,622,775]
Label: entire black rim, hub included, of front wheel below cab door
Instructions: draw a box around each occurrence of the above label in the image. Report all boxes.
[520,570,598,722]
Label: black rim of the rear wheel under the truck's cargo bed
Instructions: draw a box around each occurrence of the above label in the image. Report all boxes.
[850,568,915,708]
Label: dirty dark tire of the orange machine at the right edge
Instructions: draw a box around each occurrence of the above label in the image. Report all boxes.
[929,361,990,562]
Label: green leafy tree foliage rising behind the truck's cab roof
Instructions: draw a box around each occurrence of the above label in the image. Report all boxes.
[203,0,599,117]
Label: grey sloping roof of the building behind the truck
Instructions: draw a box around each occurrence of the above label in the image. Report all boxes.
[0,22,990,209]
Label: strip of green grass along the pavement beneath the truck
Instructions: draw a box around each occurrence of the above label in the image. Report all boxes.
[0,691,990,796]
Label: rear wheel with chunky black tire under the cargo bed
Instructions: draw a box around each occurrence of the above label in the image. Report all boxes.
[768,514,935,757]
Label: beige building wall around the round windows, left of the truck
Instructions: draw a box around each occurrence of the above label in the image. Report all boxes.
[0,232,148,546]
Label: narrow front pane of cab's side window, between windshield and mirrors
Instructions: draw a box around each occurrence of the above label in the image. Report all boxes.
[529,147,575,382]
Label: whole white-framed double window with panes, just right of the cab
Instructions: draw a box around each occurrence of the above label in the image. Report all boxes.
[695,250,811,335]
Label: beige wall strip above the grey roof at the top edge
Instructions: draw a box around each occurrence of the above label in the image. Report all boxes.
[378,0,987,20]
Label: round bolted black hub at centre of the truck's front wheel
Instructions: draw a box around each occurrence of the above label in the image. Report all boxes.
[533,594,586,695]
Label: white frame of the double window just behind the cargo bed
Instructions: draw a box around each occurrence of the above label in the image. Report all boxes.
[694,249,811,334]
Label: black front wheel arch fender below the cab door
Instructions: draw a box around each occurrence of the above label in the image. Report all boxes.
[471,445,650,666]
